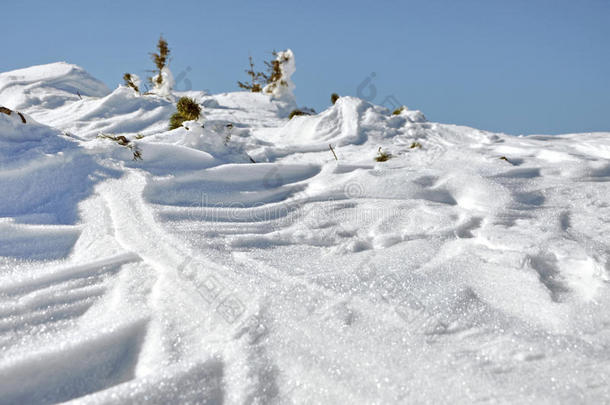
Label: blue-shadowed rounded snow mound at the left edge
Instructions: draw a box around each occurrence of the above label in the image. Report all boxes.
[0,114,114,224]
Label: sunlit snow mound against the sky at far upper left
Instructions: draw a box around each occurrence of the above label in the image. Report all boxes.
[0,62,109,113]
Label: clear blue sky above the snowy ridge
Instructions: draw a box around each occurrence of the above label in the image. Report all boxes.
[0,0,610,134]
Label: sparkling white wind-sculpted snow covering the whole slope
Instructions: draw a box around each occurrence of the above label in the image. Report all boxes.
[0,63,610,404]
